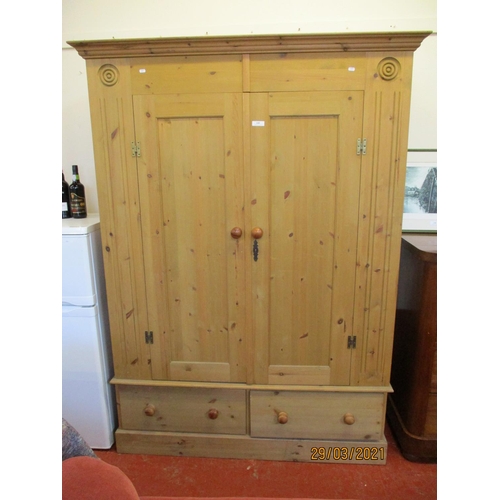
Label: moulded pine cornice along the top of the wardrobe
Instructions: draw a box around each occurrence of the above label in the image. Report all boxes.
[67,31,432,59]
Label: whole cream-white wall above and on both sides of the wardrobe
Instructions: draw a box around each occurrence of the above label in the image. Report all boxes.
[62,0,437,212]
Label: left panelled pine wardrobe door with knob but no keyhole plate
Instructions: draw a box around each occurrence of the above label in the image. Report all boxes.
[134,93,249,382]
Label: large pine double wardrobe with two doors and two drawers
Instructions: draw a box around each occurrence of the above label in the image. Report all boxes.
[69,33,428,464]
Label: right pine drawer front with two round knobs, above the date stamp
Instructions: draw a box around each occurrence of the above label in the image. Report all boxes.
[250,391,386,440]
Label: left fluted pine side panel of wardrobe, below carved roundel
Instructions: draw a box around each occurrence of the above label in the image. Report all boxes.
[87,60,151,379]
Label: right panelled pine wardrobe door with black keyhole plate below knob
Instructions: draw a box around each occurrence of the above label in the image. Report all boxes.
[247,91,363,385]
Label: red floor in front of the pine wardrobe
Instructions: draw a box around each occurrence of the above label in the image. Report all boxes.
[95,425,437,500]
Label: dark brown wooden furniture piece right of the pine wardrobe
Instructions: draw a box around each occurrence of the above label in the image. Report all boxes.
[387,233,437,462]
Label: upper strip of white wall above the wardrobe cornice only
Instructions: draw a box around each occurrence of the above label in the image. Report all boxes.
[62,0,436,42]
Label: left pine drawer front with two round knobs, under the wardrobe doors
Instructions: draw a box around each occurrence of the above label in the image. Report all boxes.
[116,386,247,434]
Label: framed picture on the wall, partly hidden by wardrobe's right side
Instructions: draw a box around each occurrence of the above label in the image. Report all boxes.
[403,155,437,232]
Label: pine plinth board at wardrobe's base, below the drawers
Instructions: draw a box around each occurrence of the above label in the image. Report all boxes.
[115,429,387,465]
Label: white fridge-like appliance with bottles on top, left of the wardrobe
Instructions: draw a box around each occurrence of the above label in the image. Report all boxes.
[62,214,116,449]
